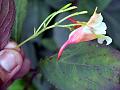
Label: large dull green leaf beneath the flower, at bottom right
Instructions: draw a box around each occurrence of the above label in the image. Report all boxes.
[40,43,120,90]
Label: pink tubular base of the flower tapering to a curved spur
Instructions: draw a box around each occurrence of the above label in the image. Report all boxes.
[57,26,96,60]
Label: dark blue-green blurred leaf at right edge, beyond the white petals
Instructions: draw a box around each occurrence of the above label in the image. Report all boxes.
[103,0,120,49]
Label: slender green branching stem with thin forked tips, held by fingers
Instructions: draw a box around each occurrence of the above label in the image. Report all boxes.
[17,4,87,47]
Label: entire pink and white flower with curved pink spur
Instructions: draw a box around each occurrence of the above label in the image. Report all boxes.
[57,8,112,60]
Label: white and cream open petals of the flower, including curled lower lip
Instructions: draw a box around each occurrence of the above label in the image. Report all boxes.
[86,8,112,45]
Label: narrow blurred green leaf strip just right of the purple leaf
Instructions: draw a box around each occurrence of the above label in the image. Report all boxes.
[12,0,28,42]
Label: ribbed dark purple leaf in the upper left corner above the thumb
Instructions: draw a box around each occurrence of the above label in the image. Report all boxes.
[0,0,15,50]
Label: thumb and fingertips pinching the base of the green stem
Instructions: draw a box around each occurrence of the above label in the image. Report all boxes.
[0,42,30,90]
